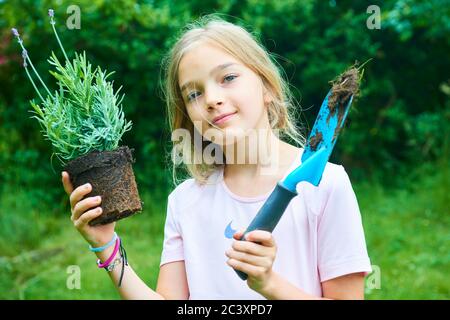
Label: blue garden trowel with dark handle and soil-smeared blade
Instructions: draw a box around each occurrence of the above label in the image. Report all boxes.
[235,69,359,280]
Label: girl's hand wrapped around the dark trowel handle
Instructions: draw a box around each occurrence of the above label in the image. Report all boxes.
[225,230,277,292]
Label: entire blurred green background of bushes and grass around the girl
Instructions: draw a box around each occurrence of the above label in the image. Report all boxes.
[0,0,450,299]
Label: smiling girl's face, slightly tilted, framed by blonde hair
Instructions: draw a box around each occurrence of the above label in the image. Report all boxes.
[178,43,270,145]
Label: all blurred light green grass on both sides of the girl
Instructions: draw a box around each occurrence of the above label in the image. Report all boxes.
[0,165,450,299]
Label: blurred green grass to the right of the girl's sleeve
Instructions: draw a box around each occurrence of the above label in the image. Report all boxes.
[355,161,450,299]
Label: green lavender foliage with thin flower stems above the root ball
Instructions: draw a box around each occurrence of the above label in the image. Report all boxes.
[12,9,132,165]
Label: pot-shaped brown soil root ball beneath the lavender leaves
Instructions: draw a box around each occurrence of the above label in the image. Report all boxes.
[65,146,142,226]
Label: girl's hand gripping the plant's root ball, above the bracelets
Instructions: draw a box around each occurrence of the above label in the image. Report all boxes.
[62,171,116,248]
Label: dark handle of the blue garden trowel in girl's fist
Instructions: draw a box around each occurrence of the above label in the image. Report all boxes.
[235,183,297,280]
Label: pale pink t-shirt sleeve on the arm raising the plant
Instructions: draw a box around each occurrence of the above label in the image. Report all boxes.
[159,197,184,267]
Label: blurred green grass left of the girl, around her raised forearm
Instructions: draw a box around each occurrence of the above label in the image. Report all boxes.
[0,189,165,299]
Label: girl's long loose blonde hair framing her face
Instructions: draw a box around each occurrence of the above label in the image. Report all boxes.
[162,14,305,185]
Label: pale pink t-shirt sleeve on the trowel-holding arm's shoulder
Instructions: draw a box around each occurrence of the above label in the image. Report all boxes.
[318,166,372,282]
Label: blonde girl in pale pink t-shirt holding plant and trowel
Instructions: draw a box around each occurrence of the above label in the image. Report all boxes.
[62,16,371,299]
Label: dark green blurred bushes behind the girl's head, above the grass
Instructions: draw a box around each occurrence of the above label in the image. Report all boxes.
[0,0,450,203]
